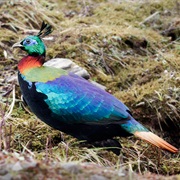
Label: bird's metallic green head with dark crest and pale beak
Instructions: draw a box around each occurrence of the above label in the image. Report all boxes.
[12,22,52,56]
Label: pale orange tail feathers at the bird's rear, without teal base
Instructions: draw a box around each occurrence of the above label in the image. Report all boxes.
[134,131,178,153]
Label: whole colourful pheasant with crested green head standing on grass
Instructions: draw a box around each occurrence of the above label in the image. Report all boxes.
[12,21,178,154]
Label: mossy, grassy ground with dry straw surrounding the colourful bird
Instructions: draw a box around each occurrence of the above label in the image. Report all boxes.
[0,0,180,179]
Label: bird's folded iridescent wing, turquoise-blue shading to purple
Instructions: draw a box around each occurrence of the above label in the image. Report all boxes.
[35,74,129,124]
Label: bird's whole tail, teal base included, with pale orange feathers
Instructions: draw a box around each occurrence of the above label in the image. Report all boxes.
[121,117,178,153]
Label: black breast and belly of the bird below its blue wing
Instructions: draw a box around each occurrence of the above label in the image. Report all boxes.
[18,73,130,141]
